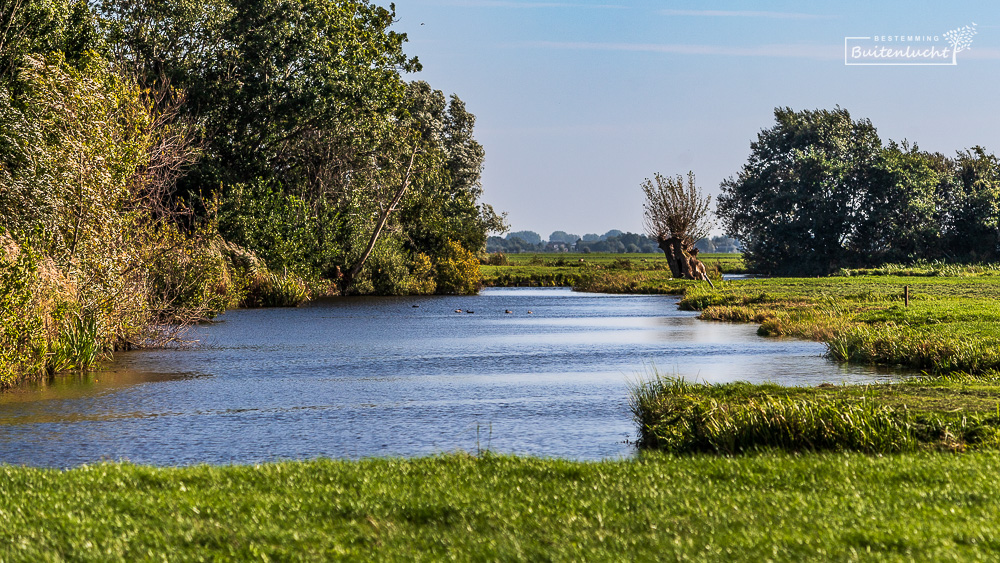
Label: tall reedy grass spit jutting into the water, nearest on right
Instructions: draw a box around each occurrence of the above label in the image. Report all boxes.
[631,372,1000,455]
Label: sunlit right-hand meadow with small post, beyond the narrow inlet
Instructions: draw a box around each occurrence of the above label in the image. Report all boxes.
[681,269,1000,373]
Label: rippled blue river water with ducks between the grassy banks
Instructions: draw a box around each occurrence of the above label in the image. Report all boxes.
[0,288,900,467]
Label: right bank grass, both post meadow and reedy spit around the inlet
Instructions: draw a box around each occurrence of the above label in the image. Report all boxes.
[608,265,1000,454]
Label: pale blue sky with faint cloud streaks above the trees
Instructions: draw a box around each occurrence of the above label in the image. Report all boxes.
[395,0,1000,237]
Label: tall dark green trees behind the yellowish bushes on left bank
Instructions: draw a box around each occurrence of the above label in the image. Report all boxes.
[102,0,503,293]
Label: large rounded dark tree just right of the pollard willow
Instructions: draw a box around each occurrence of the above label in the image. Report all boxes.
[718,108,882,274]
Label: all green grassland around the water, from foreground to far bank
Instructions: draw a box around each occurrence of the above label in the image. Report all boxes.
[0,255,1000,561]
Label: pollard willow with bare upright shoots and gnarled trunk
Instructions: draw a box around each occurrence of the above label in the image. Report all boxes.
[642,172,712,279]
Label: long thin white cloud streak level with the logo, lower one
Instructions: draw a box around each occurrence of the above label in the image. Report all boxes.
[519,41,844,60]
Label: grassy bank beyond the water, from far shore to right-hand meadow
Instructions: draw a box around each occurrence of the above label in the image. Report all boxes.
[481,255,1000,373]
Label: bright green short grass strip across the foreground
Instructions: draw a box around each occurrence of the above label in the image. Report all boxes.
[9,452,1000,561]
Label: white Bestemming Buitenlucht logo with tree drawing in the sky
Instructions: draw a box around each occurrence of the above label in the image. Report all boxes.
[844,23,976,66]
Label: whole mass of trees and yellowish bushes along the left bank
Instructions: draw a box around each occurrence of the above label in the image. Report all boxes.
[0,0,505,384]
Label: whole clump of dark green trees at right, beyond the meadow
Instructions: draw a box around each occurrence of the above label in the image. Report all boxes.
[718,108,1000,274]
